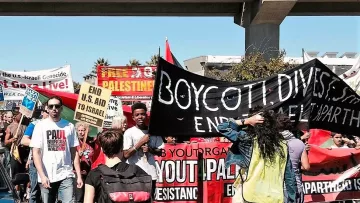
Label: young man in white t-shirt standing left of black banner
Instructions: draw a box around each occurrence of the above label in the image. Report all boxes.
[124,102,165,198]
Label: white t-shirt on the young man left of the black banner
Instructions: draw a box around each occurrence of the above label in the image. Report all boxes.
[124,126,164,180]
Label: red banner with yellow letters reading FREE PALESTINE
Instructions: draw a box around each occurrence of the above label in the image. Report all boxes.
[97,66,156,101]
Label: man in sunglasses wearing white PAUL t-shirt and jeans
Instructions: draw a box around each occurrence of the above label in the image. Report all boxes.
[30,96,83,203]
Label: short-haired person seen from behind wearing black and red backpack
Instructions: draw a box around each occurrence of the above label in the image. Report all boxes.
[84,130,152,203]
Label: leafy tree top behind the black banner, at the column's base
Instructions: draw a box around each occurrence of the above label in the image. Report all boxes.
[205,51,295,82]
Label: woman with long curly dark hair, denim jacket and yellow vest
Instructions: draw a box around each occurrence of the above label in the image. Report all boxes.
[218,107,296,203]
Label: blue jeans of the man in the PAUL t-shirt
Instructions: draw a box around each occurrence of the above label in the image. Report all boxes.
[40,178,74,203]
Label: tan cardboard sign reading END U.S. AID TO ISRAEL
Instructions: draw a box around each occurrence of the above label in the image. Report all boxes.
[74,82,111,128]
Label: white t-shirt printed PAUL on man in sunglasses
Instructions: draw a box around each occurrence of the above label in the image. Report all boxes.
[30,118,79,183]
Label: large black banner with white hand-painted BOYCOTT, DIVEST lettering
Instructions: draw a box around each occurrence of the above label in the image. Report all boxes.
[149,58,360,137]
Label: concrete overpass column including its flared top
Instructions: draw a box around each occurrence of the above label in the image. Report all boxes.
[234,0,297,59]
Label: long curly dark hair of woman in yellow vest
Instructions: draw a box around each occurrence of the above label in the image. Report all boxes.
[247,108,285,161]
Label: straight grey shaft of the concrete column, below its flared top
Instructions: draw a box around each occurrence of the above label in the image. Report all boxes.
[245,23,280,59]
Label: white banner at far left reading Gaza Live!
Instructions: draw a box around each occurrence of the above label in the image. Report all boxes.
[0,65,74,101]
